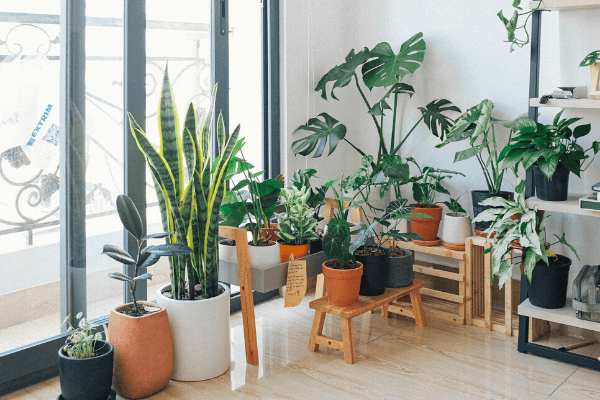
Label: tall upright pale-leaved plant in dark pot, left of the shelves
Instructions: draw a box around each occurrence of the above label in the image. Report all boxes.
[435,100,524,234]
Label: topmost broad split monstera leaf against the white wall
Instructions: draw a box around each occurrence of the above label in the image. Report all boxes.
[362,32,426,89]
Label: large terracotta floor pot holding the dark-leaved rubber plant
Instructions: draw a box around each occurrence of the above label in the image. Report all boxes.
[108,301,173,399]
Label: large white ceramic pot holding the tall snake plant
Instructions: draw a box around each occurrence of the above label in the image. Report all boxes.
[156,283,231,381]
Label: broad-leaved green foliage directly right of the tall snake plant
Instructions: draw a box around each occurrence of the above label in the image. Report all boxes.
[220,153,282,246]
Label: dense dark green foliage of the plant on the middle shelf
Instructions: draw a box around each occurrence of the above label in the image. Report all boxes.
[498,110,600,180]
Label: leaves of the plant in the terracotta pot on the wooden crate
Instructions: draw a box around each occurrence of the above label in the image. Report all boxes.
[407,157,465,206]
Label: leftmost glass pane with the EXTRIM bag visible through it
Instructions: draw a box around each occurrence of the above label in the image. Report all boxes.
[0,0,60,352]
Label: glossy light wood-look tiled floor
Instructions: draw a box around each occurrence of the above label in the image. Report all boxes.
[2,295,600,400]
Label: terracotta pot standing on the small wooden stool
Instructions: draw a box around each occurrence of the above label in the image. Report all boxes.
[323,261,363,307]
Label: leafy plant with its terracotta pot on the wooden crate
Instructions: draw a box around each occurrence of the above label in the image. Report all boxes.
[407,157,464,246]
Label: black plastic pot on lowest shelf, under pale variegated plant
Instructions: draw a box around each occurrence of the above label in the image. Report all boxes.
[527,254,571,309]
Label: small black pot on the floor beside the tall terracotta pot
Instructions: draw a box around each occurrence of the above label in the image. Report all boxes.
[58,340,114,400]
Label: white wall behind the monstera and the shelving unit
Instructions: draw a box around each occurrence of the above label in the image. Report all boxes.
[281,0,600,286]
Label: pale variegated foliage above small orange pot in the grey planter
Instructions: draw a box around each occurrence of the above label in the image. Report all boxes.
[275,188,319,245]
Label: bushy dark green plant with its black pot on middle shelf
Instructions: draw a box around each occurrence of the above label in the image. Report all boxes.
[498,110,600,201]
